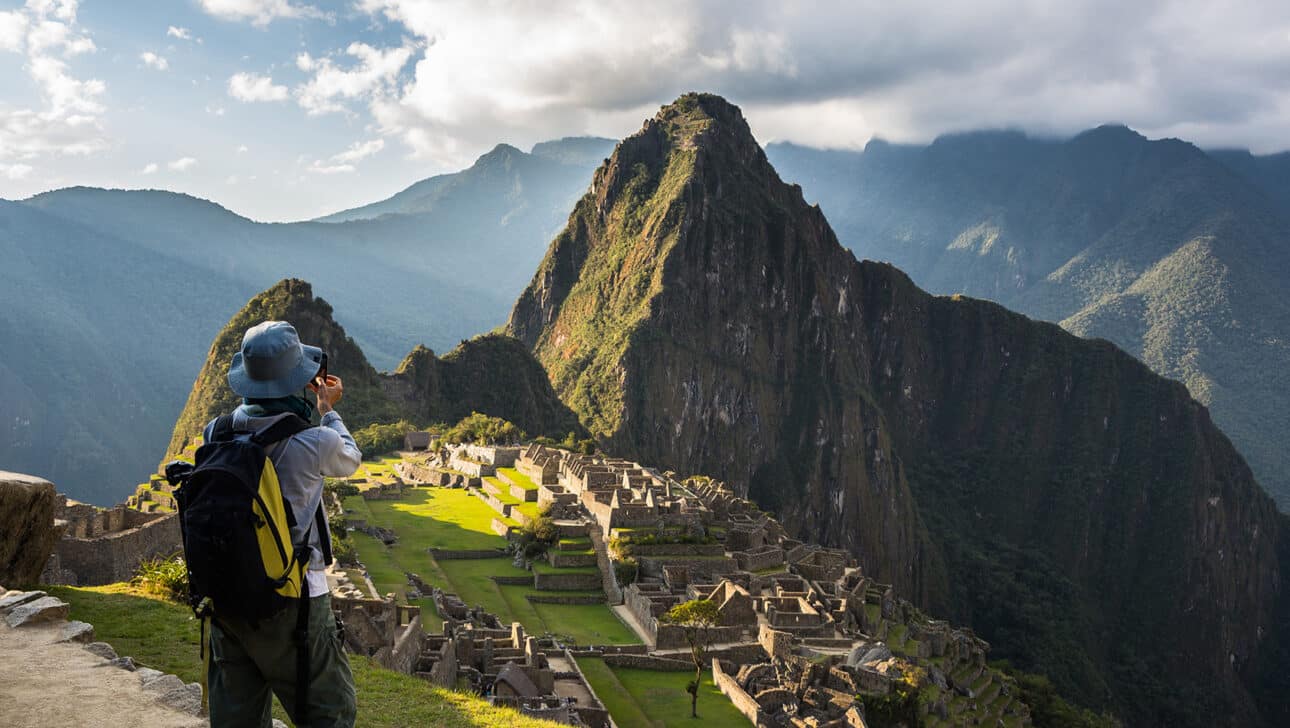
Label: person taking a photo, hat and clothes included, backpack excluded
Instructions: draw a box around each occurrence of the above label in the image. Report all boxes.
[204,321,362,728]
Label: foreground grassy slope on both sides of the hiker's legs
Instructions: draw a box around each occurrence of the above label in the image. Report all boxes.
[45,583,560,728]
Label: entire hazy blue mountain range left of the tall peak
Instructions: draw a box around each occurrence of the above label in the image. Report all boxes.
[0,139,608,505]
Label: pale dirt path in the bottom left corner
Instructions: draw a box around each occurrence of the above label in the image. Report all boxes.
[0,620,209,728]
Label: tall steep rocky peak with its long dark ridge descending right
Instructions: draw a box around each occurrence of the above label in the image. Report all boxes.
[508,94,1290,725]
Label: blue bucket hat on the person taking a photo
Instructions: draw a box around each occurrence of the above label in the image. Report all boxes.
[228,321,323,399]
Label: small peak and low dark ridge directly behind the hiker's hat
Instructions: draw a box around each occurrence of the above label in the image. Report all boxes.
[168,279,579,457]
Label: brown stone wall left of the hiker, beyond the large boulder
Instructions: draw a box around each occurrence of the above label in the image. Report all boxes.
[55,514,183,586]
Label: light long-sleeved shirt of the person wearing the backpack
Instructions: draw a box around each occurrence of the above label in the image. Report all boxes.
[204,407,362,596]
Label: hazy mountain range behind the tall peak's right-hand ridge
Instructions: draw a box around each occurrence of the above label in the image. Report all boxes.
[768,126,1290,509]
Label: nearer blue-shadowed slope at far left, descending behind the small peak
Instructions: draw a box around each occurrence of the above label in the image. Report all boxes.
[0,201,253,503]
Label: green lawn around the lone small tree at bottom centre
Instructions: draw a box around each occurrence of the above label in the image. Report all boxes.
[578,657,749,728]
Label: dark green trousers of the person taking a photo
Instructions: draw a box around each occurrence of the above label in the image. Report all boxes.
[206,594,357,728]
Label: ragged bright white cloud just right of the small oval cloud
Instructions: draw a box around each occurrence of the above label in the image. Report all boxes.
[295,43,415,115]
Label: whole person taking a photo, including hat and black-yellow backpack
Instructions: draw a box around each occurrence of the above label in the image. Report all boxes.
[188,321,362,728]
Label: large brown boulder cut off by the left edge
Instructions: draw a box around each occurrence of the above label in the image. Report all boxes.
[0,471,62,586]
